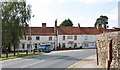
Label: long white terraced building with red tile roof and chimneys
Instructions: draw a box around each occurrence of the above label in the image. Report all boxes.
[19,23,117,50]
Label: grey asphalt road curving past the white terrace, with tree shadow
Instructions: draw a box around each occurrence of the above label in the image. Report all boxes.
[2,49,95,68]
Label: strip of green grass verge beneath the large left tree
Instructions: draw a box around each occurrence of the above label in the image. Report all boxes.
[0,52,43,61]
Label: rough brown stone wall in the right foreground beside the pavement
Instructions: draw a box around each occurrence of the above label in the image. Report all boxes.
[96,32,120,69]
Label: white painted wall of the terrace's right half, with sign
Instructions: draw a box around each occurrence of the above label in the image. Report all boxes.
[58,35,96,48]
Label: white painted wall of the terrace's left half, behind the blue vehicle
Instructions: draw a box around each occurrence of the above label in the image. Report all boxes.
[19,35,54,50]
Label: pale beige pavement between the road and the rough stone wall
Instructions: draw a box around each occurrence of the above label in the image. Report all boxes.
[68,55,103,68]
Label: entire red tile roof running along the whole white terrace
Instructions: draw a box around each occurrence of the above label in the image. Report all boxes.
[27,26,117,35]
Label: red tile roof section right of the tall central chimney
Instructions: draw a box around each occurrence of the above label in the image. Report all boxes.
[58,27,100,34]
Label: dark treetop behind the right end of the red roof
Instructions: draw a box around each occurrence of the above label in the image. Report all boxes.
[95,15,108,29]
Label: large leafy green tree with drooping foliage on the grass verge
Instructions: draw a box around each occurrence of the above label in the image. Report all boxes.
[2,2,31,56]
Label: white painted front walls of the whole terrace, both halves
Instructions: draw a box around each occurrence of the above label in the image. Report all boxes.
[19,34,97,50]
